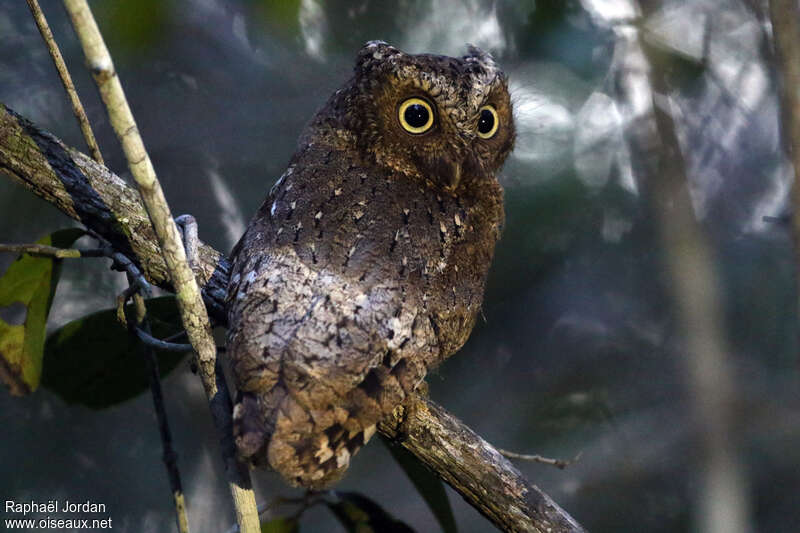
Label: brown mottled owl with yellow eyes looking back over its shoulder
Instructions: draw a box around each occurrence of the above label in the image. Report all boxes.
[222,41,514,489]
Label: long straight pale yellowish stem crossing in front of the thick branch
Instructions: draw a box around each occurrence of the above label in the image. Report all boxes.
[64,0,260,533]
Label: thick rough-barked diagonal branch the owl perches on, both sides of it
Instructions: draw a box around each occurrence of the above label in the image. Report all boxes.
[0,104,584,533]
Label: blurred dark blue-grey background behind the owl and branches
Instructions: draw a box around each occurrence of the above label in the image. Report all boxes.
[0,0,800,532]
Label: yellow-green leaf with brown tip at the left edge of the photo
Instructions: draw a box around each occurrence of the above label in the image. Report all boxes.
[0,228,83,396]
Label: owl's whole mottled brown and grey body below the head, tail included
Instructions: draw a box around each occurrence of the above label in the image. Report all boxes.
[228,141,502,486]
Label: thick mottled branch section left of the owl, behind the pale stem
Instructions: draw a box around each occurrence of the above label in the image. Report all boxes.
[0,104,230,323]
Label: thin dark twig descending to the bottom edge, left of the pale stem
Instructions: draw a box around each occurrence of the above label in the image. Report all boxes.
[128,284,189,533]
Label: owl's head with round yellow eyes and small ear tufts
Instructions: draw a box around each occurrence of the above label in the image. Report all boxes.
[310,41,514,193]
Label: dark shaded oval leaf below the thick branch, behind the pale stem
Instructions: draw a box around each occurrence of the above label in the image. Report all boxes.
[42,296,186,409]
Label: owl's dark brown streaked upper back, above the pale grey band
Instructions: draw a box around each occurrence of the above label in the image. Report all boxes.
[262,143,503,364]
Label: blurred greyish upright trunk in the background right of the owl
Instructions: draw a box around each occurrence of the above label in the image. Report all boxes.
[612,10,753,533]
